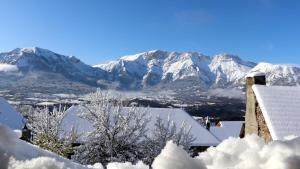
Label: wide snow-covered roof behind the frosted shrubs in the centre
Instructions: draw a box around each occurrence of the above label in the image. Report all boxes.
[63,106,219,146]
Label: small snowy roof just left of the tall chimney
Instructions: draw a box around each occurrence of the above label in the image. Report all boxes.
[210,121,244,141]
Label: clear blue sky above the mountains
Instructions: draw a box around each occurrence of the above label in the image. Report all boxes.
[0,0,300,64]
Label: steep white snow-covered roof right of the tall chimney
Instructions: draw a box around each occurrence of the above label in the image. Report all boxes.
[252,85,300,140]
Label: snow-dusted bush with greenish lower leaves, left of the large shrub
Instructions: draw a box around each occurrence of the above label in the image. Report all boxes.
[29,106,74,157]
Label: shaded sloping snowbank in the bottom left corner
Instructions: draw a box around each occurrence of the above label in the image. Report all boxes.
[0,124,98,169]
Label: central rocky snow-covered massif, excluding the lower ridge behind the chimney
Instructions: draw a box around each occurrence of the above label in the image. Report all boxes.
[95,50,255,88]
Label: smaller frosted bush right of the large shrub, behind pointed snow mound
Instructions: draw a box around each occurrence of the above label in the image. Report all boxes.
[143,117,195,165]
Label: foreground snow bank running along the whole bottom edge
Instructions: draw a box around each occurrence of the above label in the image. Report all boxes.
[0,124,300,169]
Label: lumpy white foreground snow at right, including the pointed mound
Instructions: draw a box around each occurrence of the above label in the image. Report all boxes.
[152,135,300,169]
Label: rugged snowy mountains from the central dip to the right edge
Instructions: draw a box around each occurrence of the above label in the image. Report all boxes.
[94,50,300,89]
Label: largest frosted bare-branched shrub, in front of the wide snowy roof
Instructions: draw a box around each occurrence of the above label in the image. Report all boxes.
[73,90,149,165]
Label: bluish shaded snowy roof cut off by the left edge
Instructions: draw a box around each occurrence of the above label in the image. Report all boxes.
[0,97,24,130]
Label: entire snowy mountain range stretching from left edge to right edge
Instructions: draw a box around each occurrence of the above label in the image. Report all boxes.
[0,47,300,96]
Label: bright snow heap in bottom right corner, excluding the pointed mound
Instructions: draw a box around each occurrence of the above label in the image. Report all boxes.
[196,135,300,169]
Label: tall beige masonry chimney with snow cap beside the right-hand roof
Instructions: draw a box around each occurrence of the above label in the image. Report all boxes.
[245,72,266,135]
